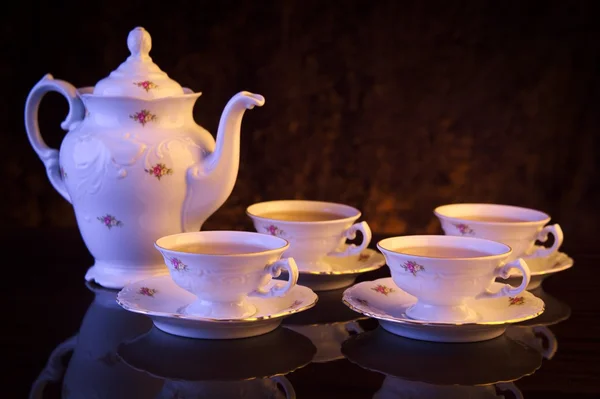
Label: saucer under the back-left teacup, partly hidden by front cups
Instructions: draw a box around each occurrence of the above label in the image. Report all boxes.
[282,249,385,291]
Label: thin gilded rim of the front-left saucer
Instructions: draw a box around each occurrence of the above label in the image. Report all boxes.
[116,275,319,324]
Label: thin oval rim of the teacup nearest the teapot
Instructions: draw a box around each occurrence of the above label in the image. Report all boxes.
[154,230,290,258]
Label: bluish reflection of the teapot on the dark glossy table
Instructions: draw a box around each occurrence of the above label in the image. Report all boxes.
[30,285,163,399]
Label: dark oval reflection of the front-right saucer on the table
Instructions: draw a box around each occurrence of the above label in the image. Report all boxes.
[342,327,542,385]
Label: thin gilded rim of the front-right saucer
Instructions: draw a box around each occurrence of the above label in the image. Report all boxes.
[342,277,546,327]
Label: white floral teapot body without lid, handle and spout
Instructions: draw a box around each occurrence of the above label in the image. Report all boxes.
[59,95,215,288]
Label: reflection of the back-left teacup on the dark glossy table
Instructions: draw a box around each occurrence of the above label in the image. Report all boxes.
[286,321,363,363]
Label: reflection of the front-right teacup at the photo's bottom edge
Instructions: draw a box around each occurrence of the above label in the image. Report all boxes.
[373,376,523,399]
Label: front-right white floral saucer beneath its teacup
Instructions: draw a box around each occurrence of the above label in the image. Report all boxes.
[343,277,544,342]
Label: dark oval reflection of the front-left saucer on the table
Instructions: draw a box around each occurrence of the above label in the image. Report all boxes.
[117,328,316,381]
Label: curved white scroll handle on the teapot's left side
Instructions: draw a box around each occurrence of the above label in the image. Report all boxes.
[25,74,85,202]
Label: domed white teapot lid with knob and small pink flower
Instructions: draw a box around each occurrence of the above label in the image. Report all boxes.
[93,27,184,99]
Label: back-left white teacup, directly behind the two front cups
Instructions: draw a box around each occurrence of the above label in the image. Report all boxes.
[246,200,371,271]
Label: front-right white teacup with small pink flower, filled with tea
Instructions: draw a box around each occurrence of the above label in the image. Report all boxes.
[377,235,530,323]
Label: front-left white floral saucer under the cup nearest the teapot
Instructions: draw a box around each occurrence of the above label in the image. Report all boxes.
[117,276,317,339]
